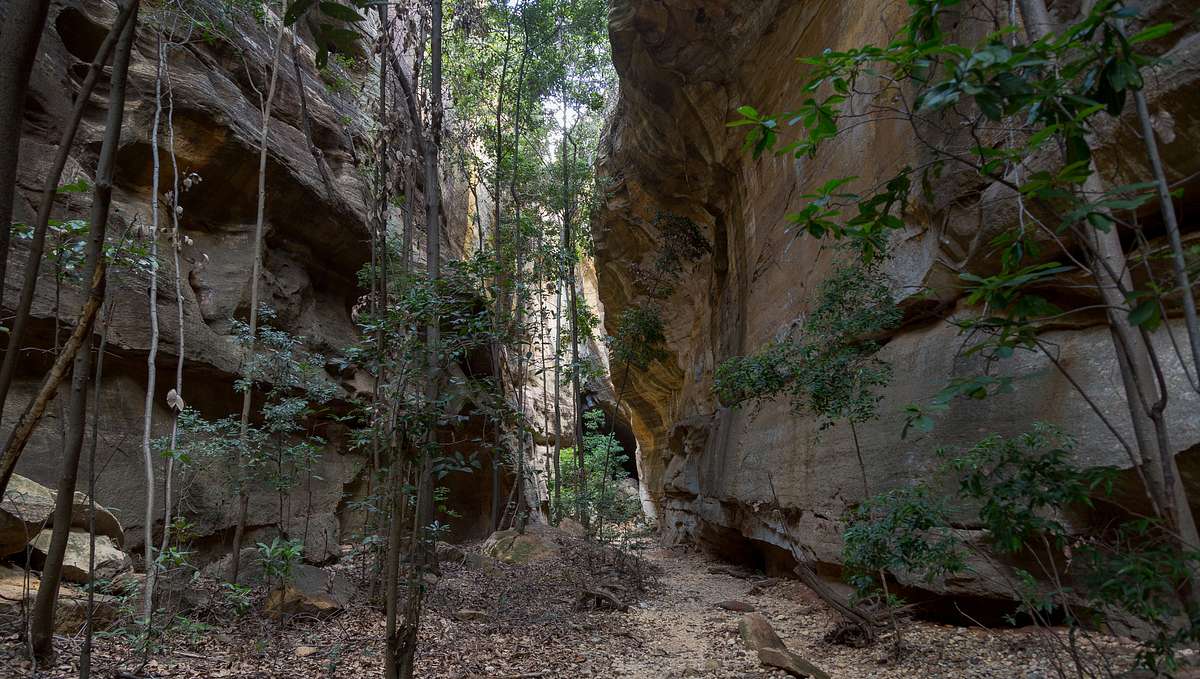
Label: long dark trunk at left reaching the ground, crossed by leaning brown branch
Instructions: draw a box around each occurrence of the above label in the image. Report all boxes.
[30,0,138,659]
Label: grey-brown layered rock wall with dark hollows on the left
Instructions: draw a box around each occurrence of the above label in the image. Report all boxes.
[0,0,540,561]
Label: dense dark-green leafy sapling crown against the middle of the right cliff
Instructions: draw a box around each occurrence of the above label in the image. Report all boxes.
[714,263,901,428]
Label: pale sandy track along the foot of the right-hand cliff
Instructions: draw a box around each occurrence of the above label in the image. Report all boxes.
[566,551,1129,679]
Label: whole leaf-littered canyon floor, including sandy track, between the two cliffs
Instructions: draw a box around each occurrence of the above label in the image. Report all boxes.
[0,541,1129,679]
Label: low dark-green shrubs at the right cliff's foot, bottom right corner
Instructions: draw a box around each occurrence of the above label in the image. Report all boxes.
[842,422,1200,675]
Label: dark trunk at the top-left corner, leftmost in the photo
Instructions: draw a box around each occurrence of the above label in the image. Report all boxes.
[0,0,50,314]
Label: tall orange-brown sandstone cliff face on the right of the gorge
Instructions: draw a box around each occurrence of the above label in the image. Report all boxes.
[593,0,1200,594]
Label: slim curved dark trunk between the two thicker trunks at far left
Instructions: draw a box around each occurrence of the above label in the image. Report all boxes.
[0,0,138,482]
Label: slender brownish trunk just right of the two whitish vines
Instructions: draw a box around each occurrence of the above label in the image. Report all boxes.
[229,11,287,583]
